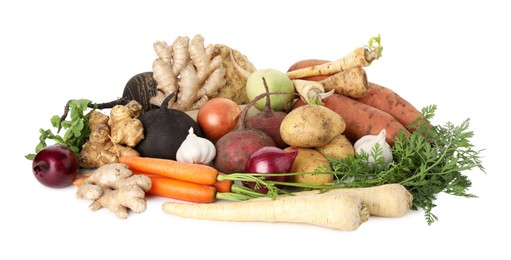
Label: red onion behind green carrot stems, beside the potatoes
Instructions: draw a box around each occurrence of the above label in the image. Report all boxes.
[242,146,298,194]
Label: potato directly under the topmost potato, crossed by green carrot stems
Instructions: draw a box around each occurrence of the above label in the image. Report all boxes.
[284,147,334,184]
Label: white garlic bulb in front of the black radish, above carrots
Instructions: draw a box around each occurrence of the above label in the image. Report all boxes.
[176,128,216,164]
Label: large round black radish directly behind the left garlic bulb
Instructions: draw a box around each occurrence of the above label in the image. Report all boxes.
[135,93,203,160]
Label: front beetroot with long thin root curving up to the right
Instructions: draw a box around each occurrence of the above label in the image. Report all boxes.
[214,79,289,173]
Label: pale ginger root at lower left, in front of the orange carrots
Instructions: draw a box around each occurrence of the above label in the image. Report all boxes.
[76,163,152,219]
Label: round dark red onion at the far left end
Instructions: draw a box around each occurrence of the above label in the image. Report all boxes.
[32,144,79,188]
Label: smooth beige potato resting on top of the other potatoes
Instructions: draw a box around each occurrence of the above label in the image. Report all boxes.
[280,105,346,148]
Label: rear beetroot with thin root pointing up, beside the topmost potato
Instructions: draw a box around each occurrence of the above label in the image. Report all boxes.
[246,78,288,149]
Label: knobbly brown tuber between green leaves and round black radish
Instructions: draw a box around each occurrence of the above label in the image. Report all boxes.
[80,101,144,168]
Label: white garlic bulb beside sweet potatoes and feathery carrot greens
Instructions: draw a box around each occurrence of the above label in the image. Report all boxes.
[353,129,393,168]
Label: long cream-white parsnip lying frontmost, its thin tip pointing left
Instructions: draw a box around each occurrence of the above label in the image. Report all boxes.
[162,190,369,231]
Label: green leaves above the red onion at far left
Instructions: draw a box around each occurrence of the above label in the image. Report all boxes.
[25,99,91,160]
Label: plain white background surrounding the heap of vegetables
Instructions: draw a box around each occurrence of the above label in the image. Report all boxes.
[0,0,511,259]
